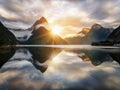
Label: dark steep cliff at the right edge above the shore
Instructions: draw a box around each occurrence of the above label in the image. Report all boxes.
[107,26,120,43]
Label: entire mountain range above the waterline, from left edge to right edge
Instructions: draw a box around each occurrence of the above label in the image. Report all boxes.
[0,17,120,45]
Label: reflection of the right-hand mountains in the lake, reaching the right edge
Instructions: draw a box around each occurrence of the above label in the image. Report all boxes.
[68,49,120,66]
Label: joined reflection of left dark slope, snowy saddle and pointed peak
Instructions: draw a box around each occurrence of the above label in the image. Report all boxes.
[0,47,61,72]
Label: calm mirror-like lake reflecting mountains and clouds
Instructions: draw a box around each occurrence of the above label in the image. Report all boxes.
[0,45,120,90]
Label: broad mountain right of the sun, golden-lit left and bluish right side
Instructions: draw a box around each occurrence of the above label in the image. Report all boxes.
[65,24,113,44]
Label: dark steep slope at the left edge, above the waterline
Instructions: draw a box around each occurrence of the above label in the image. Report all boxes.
[0,22,17,46]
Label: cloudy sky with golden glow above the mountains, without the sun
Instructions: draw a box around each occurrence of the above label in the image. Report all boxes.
[0,0,120,35]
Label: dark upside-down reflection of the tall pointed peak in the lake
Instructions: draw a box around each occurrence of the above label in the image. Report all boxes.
[27,47,61,72]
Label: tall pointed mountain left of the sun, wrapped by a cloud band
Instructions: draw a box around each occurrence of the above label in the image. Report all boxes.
[23,17,67,45]
